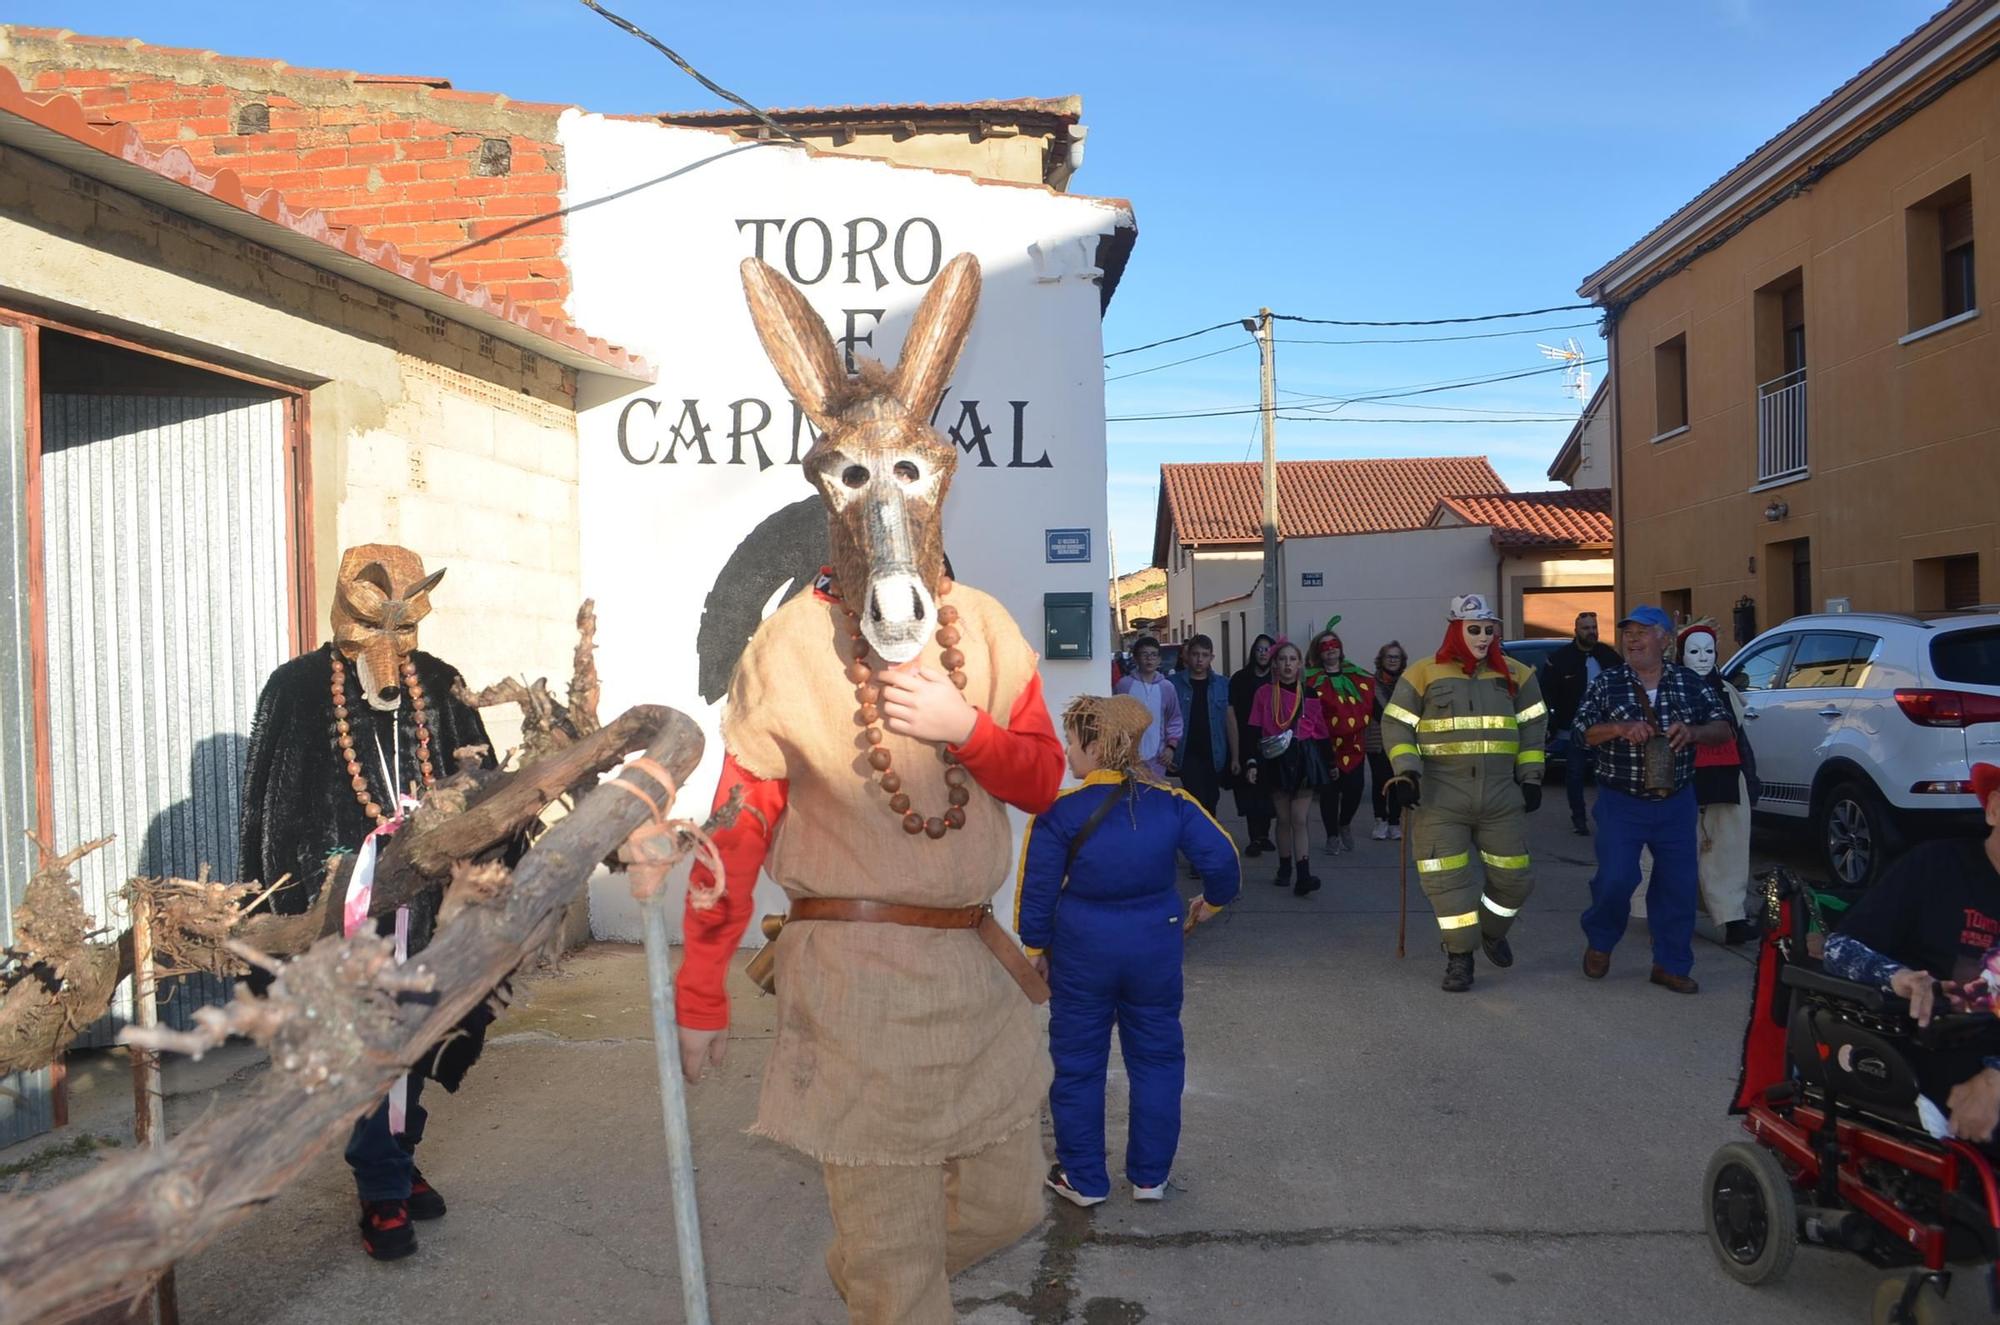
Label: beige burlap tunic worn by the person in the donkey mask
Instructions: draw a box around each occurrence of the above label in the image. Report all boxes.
[722,584,1050,1165]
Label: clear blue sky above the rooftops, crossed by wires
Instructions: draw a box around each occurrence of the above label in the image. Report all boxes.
[8,0,1940,568]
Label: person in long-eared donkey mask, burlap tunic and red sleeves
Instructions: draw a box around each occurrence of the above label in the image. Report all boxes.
[676,254,1064,1325]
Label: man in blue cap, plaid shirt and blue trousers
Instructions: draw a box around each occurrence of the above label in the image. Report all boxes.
[1570,606,1734,993]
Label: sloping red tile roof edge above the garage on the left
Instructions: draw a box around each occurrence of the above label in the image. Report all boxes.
[0,67,652,376]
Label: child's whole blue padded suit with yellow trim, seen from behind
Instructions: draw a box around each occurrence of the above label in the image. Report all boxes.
[1014,773,1242,1197]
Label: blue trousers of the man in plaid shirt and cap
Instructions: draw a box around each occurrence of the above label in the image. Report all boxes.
[1584,787,1700,975]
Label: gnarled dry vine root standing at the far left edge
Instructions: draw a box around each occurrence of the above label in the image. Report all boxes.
[0,835,120,1077]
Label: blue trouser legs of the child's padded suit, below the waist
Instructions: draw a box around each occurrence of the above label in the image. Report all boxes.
[1048,891,1188,1197]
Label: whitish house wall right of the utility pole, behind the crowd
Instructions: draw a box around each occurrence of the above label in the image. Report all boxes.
[1284,526,1500,667]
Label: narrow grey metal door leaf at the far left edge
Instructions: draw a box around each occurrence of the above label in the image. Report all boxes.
[0,326,54,1145]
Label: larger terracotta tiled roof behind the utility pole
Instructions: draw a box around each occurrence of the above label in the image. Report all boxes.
[1154,456,1506,562]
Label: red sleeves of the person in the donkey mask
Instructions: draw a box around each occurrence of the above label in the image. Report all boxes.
[674,677,1064,1031]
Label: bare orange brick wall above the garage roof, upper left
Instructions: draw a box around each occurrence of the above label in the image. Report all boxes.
[0,26,570,314]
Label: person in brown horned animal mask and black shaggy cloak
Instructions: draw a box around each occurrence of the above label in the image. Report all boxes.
[238,542,492,1261]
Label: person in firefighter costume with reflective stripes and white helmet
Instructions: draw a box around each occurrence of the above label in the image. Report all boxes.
[1382,594,1548,993]
